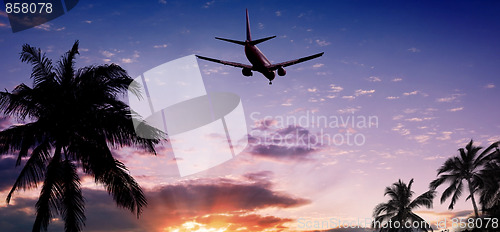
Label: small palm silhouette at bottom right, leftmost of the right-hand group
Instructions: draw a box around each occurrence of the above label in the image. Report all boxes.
[372,179,436,232]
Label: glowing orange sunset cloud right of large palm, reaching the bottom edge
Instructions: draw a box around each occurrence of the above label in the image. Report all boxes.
[143,176,310,231]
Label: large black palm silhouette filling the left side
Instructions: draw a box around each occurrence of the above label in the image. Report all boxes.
[0,41,162,232]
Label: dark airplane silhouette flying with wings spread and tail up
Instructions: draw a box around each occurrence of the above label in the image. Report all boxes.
[196,9,324,85]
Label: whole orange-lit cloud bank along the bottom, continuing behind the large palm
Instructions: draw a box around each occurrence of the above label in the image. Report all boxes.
[0,175,310,232]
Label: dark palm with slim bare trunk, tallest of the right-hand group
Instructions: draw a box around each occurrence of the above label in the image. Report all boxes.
[429,140,500,218]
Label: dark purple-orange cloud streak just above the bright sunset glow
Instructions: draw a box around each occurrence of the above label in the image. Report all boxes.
[149,178,309,215]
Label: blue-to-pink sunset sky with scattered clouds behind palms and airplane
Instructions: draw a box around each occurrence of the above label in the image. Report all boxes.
[0,0,500,232]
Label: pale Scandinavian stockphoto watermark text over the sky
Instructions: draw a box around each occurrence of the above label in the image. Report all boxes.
[250,111,379,149]
